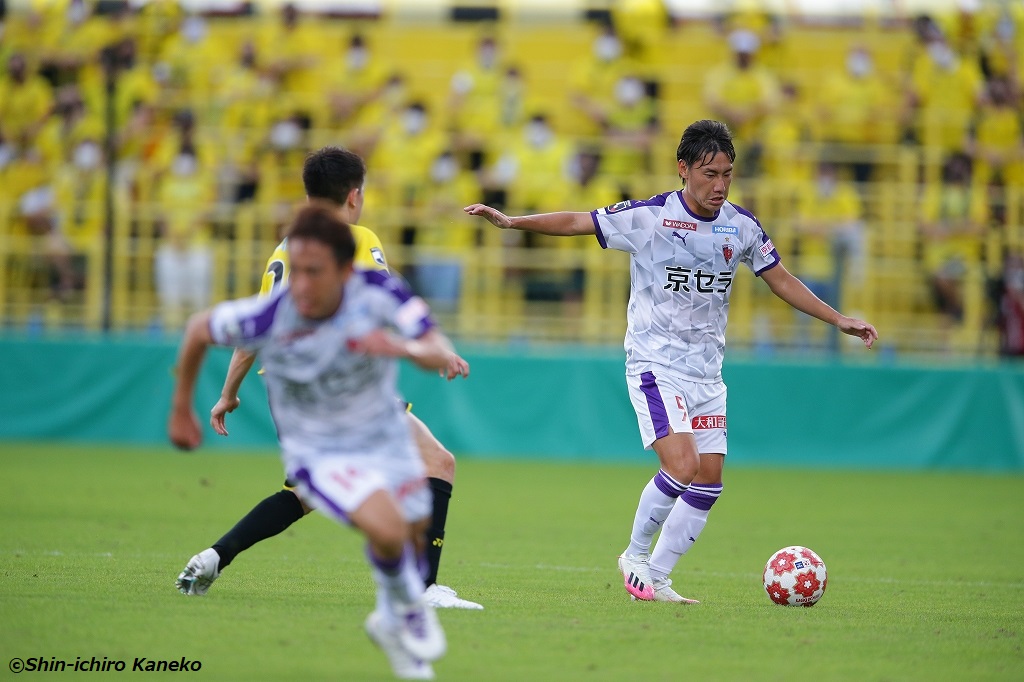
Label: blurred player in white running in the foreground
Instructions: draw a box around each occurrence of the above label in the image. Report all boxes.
[168,204,469,679]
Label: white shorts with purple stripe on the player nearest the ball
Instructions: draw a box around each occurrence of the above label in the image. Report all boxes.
[626,372,728,455]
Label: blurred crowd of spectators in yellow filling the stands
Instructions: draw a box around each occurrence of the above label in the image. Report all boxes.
[0,0,1024,353]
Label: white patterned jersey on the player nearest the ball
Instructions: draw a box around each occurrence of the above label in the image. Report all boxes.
[591,190,779,382]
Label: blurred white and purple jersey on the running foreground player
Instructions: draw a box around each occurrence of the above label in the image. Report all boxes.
[210,269,434,468]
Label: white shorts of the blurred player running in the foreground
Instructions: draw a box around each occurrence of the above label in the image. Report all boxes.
[287,455,432,523]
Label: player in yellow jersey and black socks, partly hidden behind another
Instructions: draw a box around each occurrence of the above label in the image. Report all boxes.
[176,146,483,609]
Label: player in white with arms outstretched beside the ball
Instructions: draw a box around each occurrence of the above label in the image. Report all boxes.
[465,120,878,603]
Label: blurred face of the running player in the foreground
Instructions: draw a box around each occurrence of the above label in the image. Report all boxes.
[288,240,352,319]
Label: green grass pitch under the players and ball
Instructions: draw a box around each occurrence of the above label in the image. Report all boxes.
[0,443,1024,681]
